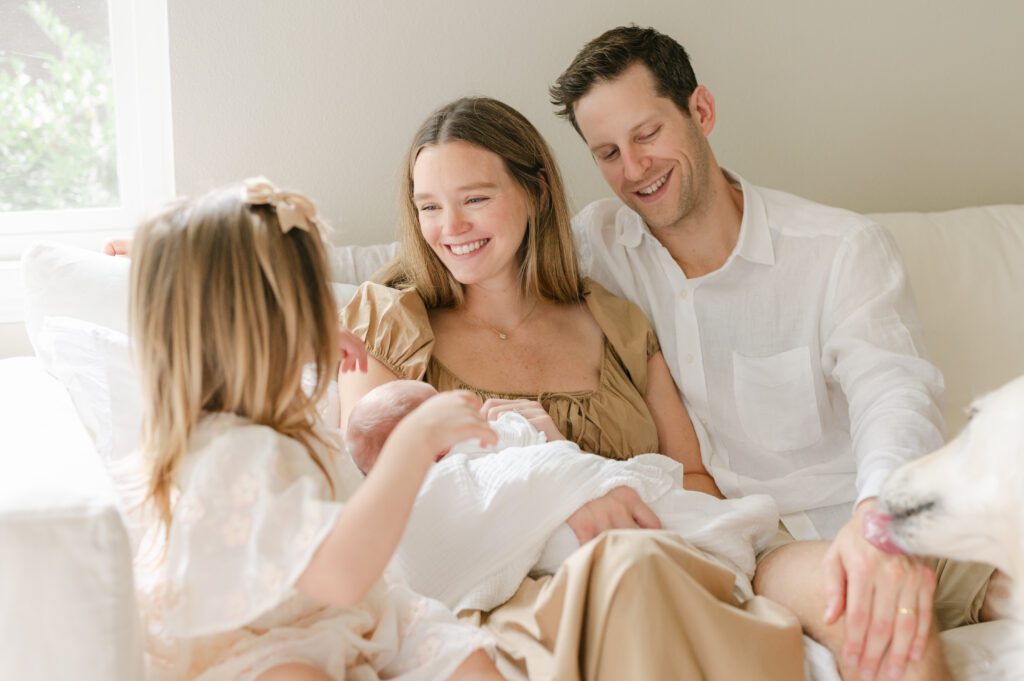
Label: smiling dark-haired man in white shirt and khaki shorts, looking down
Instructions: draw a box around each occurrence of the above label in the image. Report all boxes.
[551,27,991,679]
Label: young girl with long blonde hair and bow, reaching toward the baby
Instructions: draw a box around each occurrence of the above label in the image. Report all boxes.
[125,178,501,681]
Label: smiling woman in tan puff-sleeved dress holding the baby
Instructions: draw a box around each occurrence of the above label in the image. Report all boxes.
[340,98,802,679]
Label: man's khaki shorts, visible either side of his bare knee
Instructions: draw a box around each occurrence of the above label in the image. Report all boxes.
[758,523,994,631]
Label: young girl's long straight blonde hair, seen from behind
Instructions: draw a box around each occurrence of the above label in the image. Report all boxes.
[130,180,339,531]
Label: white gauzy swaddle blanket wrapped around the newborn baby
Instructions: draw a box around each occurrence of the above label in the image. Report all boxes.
[390,413,778,612]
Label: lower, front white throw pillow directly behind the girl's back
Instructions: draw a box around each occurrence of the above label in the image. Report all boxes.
[34,316,142,463]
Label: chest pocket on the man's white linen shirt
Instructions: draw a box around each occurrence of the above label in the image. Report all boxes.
[732,346,821,452]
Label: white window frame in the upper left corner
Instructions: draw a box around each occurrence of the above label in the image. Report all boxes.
[0,0,174,324]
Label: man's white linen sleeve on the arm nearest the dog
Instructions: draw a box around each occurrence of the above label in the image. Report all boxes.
[822,224,944,504]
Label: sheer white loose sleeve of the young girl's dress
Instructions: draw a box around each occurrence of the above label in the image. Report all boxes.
[164,425,342,637]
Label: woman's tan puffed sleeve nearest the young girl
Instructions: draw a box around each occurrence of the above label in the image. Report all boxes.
[341,283,434,381]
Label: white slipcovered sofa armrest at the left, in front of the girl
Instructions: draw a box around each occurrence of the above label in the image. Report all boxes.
[0,357,142,681]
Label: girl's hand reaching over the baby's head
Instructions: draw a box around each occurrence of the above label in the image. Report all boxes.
[388,390,498,461]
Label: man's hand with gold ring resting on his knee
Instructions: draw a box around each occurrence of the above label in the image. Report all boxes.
[823,499,935,679]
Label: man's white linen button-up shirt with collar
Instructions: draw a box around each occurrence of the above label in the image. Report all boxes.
[573,174,943,539]
